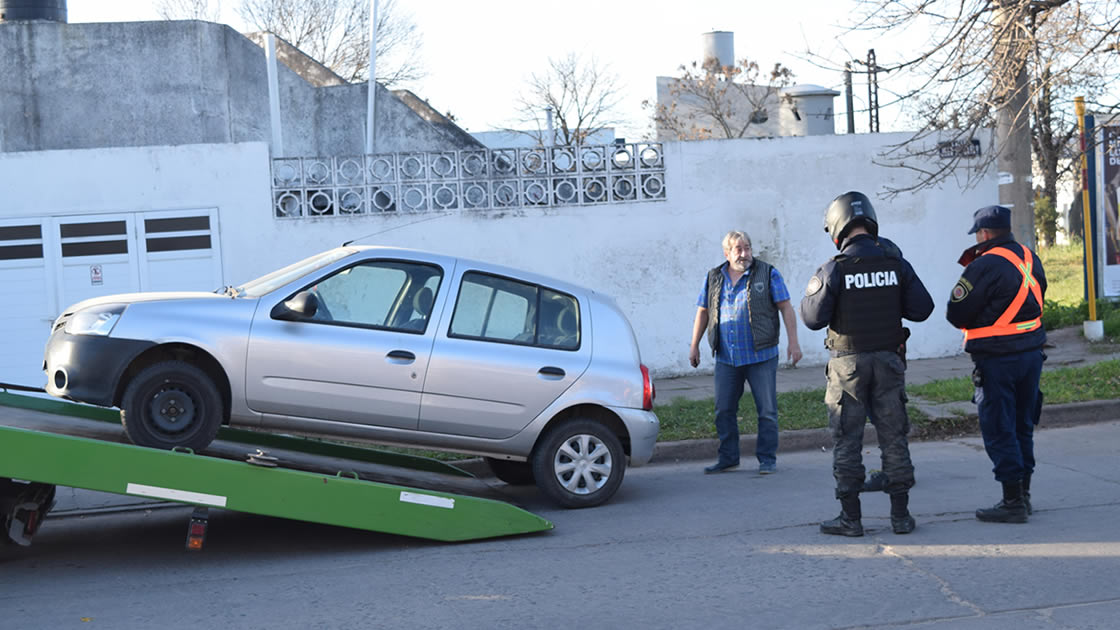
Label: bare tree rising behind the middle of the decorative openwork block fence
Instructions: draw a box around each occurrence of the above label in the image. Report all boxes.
[507,53,624,146]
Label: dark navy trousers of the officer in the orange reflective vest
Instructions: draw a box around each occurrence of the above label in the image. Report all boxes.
[973,350,1043,482]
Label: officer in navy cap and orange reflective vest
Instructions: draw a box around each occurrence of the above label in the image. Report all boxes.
[945,205,1046,522]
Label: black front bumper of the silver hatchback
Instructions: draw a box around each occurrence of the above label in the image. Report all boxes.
[43,330,155,407]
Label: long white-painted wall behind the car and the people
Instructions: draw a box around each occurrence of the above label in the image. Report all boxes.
[0,135,997,377]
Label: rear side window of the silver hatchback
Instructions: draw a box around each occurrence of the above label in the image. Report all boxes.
[449,272,579,350]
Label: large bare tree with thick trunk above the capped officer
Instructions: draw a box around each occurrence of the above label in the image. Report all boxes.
[837,0,1120,242]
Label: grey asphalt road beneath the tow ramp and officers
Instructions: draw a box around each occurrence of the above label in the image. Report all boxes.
[0,421,1120,630]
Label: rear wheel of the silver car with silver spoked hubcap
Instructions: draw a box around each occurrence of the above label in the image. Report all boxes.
[532,418,626,508]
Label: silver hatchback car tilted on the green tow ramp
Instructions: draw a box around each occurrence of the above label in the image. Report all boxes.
[44,247,659,508]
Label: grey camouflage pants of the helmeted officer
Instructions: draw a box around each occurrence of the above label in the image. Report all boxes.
[824,351,914,498]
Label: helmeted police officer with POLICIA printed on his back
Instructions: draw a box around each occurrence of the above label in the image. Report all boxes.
[801,192,933,536]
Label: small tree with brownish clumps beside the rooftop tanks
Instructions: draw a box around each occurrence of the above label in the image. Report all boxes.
[642,57,793,140]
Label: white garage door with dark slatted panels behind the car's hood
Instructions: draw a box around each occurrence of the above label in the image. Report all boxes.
[0,209,223,387]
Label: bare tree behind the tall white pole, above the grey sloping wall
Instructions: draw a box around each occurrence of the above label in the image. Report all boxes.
[236,0,424,87]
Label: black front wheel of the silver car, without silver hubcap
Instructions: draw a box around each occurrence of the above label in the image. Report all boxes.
[121,361,225,451]
